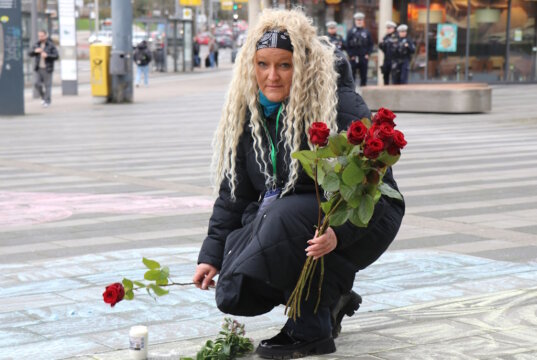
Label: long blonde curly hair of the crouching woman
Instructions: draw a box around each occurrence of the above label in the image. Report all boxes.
[211,9,338,199]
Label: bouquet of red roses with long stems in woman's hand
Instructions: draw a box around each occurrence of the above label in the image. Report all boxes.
[285,108,407,319]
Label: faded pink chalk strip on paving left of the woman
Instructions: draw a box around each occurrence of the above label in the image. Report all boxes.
[0,191,214,226]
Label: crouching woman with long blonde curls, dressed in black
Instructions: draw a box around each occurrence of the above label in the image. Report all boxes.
[193,9,404,358]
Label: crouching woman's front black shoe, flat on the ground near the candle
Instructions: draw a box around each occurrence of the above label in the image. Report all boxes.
[255,329,336,359]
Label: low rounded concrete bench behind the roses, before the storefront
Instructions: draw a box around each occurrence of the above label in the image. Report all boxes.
[360,83,492,113]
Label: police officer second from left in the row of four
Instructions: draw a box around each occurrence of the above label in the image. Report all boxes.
[346,12,373,86]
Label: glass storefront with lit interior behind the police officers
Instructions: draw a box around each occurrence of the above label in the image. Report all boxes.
[304,0,537,83]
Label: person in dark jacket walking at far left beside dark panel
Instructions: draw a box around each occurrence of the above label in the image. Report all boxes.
[28,30,59,107]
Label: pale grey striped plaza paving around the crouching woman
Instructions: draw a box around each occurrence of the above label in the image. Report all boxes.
[0,68,537,360]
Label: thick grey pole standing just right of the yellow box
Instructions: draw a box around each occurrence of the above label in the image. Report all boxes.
[109,0,133,103]
